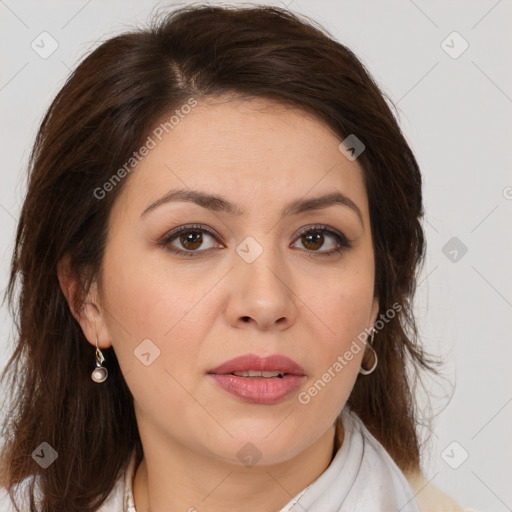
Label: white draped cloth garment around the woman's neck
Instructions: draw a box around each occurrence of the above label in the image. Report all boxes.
[0,406,421,512]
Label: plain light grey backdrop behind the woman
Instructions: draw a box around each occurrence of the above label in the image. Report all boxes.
[0,0,512,512]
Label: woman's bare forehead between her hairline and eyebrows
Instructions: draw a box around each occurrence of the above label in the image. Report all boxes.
[118,97,367,221]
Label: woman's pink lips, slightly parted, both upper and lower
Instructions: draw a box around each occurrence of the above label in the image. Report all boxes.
[208,354,307,405]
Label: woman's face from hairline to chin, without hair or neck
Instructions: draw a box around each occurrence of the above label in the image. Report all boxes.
[88,99,378,464]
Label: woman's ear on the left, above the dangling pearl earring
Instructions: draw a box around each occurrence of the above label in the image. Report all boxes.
[57,254,112,348]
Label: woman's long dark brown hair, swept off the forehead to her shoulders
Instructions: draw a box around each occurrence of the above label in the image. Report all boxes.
[2,5,440,512]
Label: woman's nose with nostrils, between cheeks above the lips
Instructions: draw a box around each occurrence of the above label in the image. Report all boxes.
[226,244,298,331]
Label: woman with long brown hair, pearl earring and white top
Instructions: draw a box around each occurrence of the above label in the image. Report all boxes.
[0,6,476,512]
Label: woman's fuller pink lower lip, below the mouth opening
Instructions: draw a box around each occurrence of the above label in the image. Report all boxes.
[208,373,306,404]
